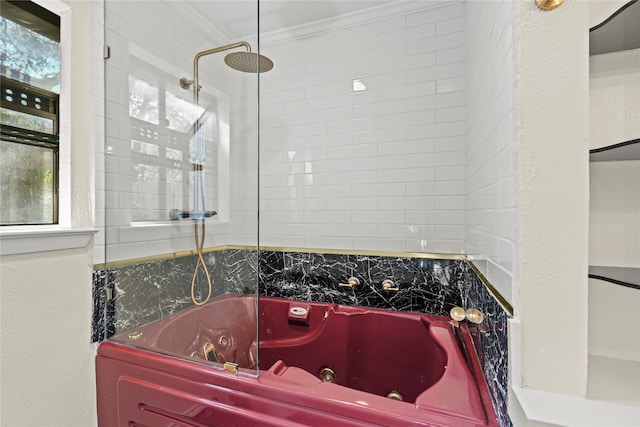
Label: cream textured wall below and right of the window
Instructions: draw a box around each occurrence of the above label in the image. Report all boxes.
[0,1,102,427]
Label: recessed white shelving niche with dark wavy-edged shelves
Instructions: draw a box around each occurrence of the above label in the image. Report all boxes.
[587,0,640,407]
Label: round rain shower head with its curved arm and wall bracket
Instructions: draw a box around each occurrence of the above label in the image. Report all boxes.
[180,41,273,100]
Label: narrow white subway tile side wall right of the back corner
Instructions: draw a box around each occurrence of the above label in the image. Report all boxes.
[462,1,518,301]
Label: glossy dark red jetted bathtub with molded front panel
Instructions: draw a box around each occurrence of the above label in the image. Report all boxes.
[96,294,499,427]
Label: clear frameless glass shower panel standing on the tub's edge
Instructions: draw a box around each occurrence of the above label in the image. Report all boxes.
[102,0,259,373]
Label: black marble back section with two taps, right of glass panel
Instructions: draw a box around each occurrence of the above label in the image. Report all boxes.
[260,251,464,315]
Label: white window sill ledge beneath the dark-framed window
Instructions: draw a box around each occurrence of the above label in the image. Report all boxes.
[0,226,98,256]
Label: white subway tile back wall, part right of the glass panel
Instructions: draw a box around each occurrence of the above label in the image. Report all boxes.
[260,2,466,253]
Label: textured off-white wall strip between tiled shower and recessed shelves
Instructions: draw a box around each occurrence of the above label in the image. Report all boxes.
[510,1,589,396]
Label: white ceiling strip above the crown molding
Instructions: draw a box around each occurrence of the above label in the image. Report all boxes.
[188,0,390,40]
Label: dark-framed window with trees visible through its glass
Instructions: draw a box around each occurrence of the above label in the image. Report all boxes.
[0,0,60,225]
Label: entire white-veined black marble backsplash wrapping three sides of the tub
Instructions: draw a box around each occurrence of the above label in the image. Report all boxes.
[92,249,511,426]
